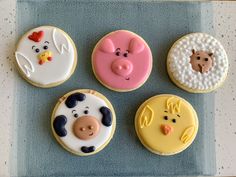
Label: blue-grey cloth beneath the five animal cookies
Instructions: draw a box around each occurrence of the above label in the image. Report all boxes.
[12,0,215,176]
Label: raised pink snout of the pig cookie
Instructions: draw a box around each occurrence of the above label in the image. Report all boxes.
[111,59,133,77]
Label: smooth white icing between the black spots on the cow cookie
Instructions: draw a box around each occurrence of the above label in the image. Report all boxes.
[54,93,113,153]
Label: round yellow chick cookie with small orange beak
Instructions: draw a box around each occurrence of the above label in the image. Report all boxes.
[135,94,198,155]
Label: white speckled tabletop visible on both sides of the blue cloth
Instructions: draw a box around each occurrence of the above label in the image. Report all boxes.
[0,0,236,177]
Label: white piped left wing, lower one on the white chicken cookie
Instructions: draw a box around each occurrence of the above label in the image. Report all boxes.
[15,52,34,77]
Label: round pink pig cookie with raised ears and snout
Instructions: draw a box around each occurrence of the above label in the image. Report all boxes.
[92,30,152,92]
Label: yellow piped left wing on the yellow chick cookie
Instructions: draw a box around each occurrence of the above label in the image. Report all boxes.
[139,105,154,128]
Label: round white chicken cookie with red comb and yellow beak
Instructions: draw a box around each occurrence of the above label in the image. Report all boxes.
[15,26,77,88]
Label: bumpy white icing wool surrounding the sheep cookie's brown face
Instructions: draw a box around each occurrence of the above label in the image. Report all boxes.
[168,33,228,91]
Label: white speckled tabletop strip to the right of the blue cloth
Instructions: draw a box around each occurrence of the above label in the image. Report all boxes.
[213,2,236,176]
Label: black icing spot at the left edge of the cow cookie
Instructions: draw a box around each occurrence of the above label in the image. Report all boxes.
[53,115,67,137]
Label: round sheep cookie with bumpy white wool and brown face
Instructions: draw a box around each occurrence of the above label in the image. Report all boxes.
[167,33,229,93]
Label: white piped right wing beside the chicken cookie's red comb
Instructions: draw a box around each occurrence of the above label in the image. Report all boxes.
[52,28,70,55]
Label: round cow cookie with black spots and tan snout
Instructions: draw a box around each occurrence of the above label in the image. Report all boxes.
[51,89,116,156]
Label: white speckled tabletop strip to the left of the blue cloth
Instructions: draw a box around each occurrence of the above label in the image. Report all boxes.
[0,0,16,176]
